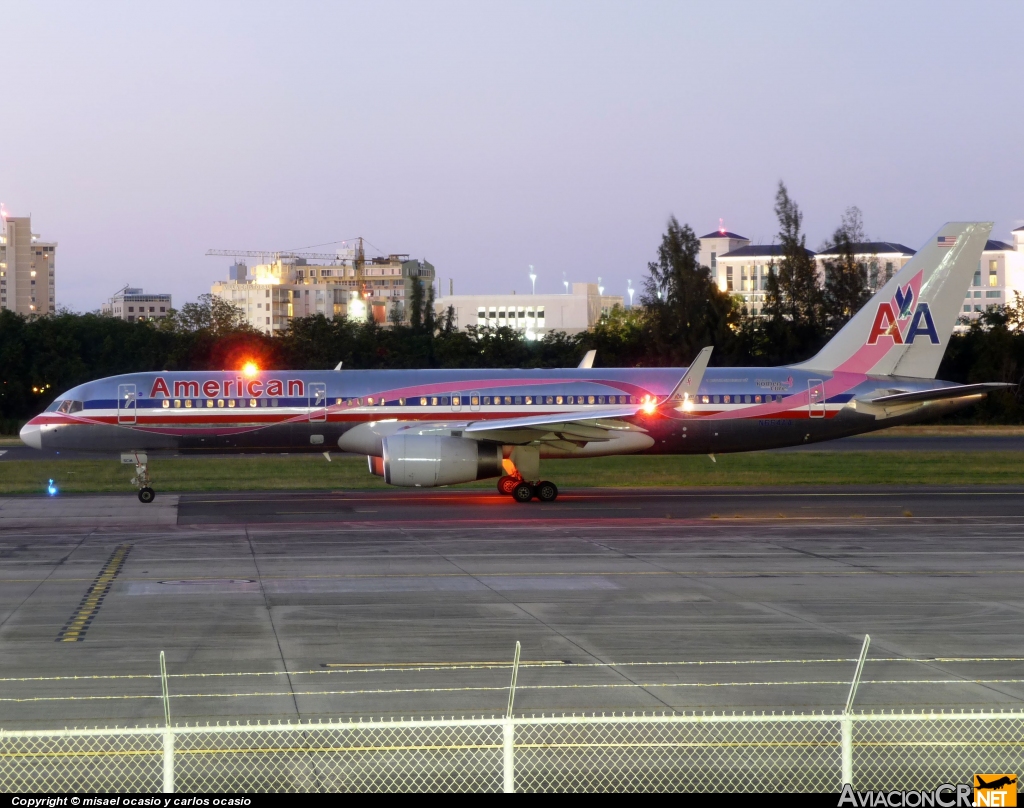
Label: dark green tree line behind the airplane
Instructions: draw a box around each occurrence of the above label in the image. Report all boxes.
[0,182,1024,433]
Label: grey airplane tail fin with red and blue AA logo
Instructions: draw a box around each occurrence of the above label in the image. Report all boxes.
[794,222,992,379]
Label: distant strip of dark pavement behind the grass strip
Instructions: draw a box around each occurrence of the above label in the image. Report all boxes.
[6,432,1024,463]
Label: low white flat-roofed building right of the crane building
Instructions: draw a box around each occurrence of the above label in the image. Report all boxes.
[434,284,623,340]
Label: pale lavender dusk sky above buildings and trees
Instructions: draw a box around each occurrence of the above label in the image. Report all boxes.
[0,0,1024,310]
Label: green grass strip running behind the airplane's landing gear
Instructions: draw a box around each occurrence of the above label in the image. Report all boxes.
[0,452,1024,495]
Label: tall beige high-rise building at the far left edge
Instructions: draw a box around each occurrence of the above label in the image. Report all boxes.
[0,211,57,316]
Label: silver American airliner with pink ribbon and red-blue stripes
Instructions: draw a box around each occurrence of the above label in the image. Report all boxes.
[20,222,1014,503]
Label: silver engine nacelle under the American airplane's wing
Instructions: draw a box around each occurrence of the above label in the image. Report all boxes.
[384,435,505,488]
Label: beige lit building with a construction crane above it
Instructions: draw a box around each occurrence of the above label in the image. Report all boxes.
[211,245,434,334]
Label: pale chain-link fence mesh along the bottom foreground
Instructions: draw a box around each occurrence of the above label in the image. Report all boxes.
[0,711,1024,793]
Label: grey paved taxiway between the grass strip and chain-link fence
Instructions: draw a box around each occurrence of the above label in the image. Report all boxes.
[0,487,1024,728]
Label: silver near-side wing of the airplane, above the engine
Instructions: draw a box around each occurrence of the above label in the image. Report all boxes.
[462,405,646,444]
